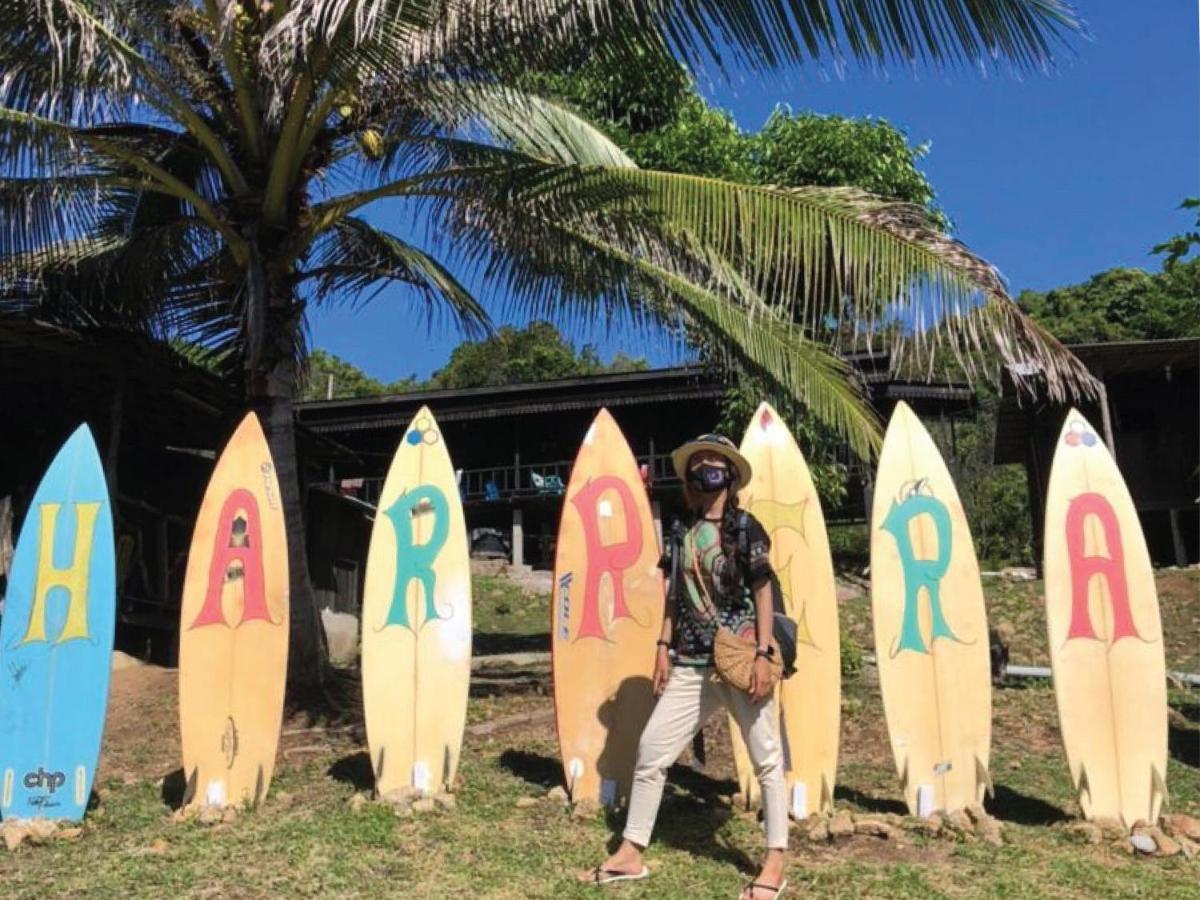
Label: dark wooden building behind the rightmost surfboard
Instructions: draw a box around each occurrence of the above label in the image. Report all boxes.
[994,338,1200,565]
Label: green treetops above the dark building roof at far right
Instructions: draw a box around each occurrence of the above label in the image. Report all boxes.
[1018,258,1200,343]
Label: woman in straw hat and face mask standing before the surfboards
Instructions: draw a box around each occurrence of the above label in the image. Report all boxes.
[580,434,787,900]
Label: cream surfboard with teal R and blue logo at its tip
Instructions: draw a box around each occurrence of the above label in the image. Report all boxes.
[362,407,470,796]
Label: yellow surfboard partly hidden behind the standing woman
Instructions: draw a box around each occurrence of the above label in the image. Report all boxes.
[730,403,841,818]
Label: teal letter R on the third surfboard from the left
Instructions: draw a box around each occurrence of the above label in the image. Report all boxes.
[384,485,450,631]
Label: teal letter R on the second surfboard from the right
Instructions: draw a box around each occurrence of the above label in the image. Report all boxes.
[882,493,958,653]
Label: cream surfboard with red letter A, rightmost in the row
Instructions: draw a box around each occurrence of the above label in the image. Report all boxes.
[1044,409,1168,827]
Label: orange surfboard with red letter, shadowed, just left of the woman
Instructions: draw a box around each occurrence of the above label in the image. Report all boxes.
[551,409,665,805]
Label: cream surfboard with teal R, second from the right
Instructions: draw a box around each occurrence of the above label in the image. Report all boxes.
[871,403,991,816]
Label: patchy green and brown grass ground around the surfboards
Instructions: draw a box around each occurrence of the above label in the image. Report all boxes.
[0,580,1200,900]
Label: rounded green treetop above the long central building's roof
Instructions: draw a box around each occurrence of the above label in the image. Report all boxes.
[430,322,646,388]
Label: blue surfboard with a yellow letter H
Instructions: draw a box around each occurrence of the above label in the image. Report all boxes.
[0,425,116,821]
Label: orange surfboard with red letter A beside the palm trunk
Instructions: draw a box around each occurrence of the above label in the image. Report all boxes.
[179,413,288,806]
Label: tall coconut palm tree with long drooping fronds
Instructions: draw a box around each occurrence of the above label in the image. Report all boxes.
[0,0,1086,683]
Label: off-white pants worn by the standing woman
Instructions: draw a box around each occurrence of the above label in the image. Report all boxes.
[624,666,787,850]
